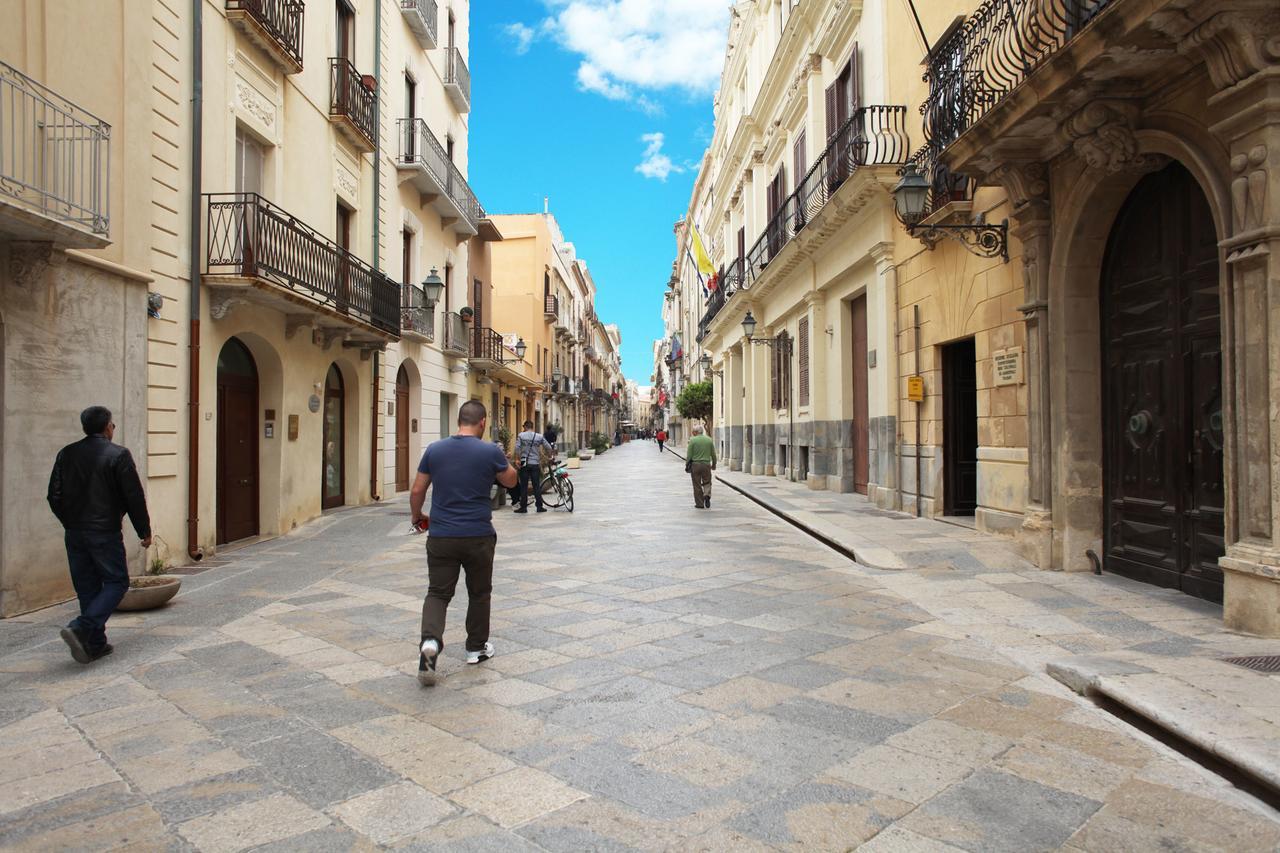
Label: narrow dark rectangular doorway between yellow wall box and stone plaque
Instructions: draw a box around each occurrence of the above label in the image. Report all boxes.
[942,338,978,515]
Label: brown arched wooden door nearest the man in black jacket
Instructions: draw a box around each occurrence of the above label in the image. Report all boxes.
[216,338,259,544]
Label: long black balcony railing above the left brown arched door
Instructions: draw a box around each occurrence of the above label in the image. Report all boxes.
[205,192,401,337]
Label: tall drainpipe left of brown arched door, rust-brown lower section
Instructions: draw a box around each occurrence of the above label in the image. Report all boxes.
[187,0,205,562]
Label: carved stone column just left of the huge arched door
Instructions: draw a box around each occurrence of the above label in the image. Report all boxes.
[993,163,1053,569]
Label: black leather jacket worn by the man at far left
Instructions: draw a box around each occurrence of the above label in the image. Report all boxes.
[49,435,151,539]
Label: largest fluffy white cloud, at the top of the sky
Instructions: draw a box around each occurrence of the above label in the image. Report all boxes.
[544,0,728,111]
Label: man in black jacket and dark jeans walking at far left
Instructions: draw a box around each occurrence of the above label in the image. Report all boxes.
[49,406,151,663]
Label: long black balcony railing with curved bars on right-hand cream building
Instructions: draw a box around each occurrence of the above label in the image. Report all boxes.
[744,106,910,286]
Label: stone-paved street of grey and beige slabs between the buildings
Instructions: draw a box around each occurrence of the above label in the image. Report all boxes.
[0,442,1280,850]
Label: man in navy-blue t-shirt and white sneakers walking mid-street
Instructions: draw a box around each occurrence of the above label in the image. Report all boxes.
[408,400,517,685]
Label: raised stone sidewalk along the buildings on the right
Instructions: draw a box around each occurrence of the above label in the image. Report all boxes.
[672,447,1280,793]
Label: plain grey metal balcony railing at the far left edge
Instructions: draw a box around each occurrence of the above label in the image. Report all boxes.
[0,63,111,237]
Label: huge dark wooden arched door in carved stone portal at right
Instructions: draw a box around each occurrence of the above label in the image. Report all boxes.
[1101,163,1225,602]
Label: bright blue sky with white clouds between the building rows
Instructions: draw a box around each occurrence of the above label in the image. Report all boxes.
[468,0,728,386]
